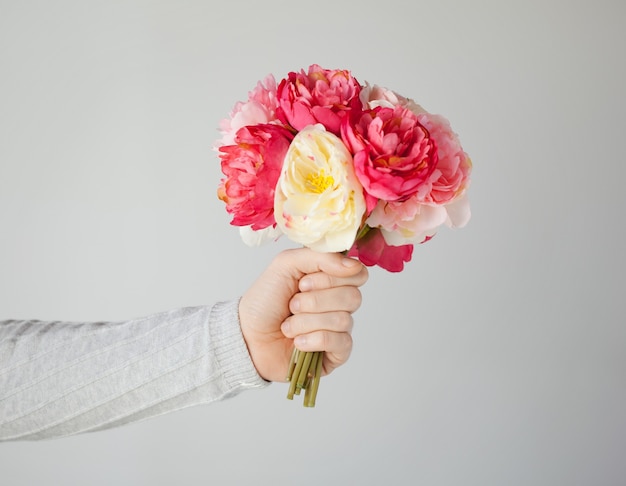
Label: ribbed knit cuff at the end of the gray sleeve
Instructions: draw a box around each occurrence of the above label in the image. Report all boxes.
[209,299,269,392]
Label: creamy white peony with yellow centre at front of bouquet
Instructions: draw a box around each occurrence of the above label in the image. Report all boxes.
[274,124,365,252]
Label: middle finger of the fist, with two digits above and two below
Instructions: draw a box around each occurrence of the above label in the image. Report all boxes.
[289,286,363,314]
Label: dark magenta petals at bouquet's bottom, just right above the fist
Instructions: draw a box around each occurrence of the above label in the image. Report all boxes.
[348,228,413,272]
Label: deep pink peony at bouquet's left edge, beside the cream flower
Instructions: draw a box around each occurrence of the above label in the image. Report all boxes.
[217,124,293,230]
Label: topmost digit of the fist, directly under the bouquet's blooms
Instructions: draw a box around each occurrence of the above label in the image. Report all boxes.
[273,248,363,279]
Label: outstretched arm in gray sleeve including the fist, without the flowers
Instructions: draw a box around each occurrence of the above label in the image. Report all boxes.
[0,249,368,441]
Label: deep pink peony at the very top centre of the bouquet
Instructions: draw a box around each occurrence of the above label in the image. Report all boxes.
[277,64,361,135]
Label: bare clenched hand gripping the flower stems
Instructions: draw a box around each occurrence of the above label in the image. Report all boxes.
[239,248,368,381]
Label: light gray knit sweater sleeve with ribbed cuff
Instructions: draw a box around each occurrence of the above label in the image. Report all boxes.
[0,301,268,441]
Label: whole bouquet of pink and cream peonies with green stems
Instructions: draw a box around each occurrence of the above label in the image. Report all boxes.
[217,64,472,407]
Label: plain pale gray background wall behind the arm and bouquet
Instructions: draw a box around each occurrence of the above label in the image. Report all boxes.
[0,0,626,486]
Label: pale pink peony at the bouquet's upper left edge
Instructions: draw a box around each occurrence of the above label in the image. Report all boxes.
[219,74,278,145]
